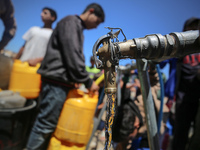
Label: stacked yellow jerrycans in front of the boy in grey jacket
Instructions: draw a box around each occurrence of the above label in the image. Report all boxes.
[48,75,104,150]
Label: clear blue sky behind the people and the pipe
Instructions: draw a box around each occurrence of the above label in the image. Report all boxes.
[0,0,200,78]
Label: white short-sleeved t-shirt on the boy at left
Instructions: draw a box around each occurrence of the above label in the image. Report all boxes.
[20,27,53,61]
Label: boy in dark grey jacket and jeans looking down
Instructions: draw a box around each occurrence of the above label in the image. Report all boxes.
[27,3,105,150]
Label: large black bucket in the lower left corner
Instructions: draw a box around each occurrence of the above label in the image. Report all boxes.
[0,100,36,150]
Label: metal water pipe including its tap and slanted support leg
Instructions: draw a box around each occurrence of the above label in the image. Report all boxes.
[93,28,200,150]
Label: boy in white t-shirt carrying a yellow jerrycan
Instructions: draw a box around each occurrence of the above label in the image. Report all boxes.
[16,7,57,66]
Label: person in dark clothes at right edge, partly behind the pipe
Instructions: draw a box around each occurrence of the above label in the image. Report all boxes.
[172,17,200,150]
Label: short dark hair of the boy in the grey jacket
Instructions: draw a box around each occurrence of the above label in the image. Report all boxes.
[82,3,105,22]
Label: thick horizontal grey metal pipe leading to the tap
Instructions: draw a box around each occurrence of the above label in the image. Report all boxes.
[96,30,200,61]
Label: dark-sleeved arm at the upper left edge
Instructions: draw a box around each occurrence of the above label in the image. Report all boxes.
[0,0,16,51]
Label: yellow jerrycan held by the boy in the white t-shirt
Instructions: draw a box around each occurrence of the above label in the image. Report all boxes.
[9,60,41,99]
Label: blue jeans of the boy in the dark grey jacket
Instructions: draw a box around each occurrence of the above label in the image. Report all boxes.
[26,82,70,150]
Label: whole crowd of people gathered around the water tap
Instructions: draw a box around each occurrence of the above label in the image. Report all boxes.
[0,0,200,150]
